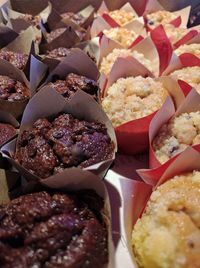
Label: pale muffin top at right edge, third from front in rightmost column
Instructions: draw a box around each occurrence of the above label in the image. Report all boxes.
[170,66,200,94]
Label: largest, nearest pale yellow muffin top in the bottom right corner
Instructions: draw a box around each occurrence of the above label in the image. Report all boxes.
[132,171,200,268]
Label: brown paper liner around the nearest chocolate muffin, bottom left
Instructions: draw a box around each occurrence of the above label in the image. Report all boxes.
[0,166,115,268]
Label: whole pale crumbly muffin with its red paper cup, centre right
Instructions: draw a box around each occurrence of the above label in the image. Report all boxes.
[102,62,184,154]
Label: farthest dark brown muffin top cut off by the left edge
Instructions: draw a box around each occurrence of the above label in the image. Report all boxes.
[0,50,28,70]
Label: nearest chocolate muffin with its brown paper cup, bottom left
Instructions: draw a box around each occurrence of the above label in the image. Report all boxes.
[1,166,115,268]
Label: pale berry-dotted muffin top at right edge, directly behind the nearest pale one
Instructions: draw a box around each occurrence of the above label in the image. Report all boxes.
[152,111,200,164]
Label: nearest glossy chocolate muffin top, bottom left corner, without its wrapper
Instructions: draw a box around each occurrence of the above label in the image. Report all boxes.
[0,190,108,268]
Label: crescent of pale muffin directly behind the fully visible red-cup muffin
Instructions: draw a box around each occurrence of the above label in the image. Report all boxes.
[100,48,155,76]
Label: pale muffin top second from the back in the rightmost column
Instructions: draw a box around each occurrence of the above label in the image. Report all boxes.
[164,24,189,44]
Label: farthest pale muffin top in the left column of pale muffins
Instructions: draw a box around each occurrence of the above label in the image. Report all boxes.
[108,9,135,26]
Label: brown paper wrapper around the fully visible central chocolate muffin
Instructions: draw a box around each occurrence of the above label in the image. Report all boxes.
[2,88,117,181]
